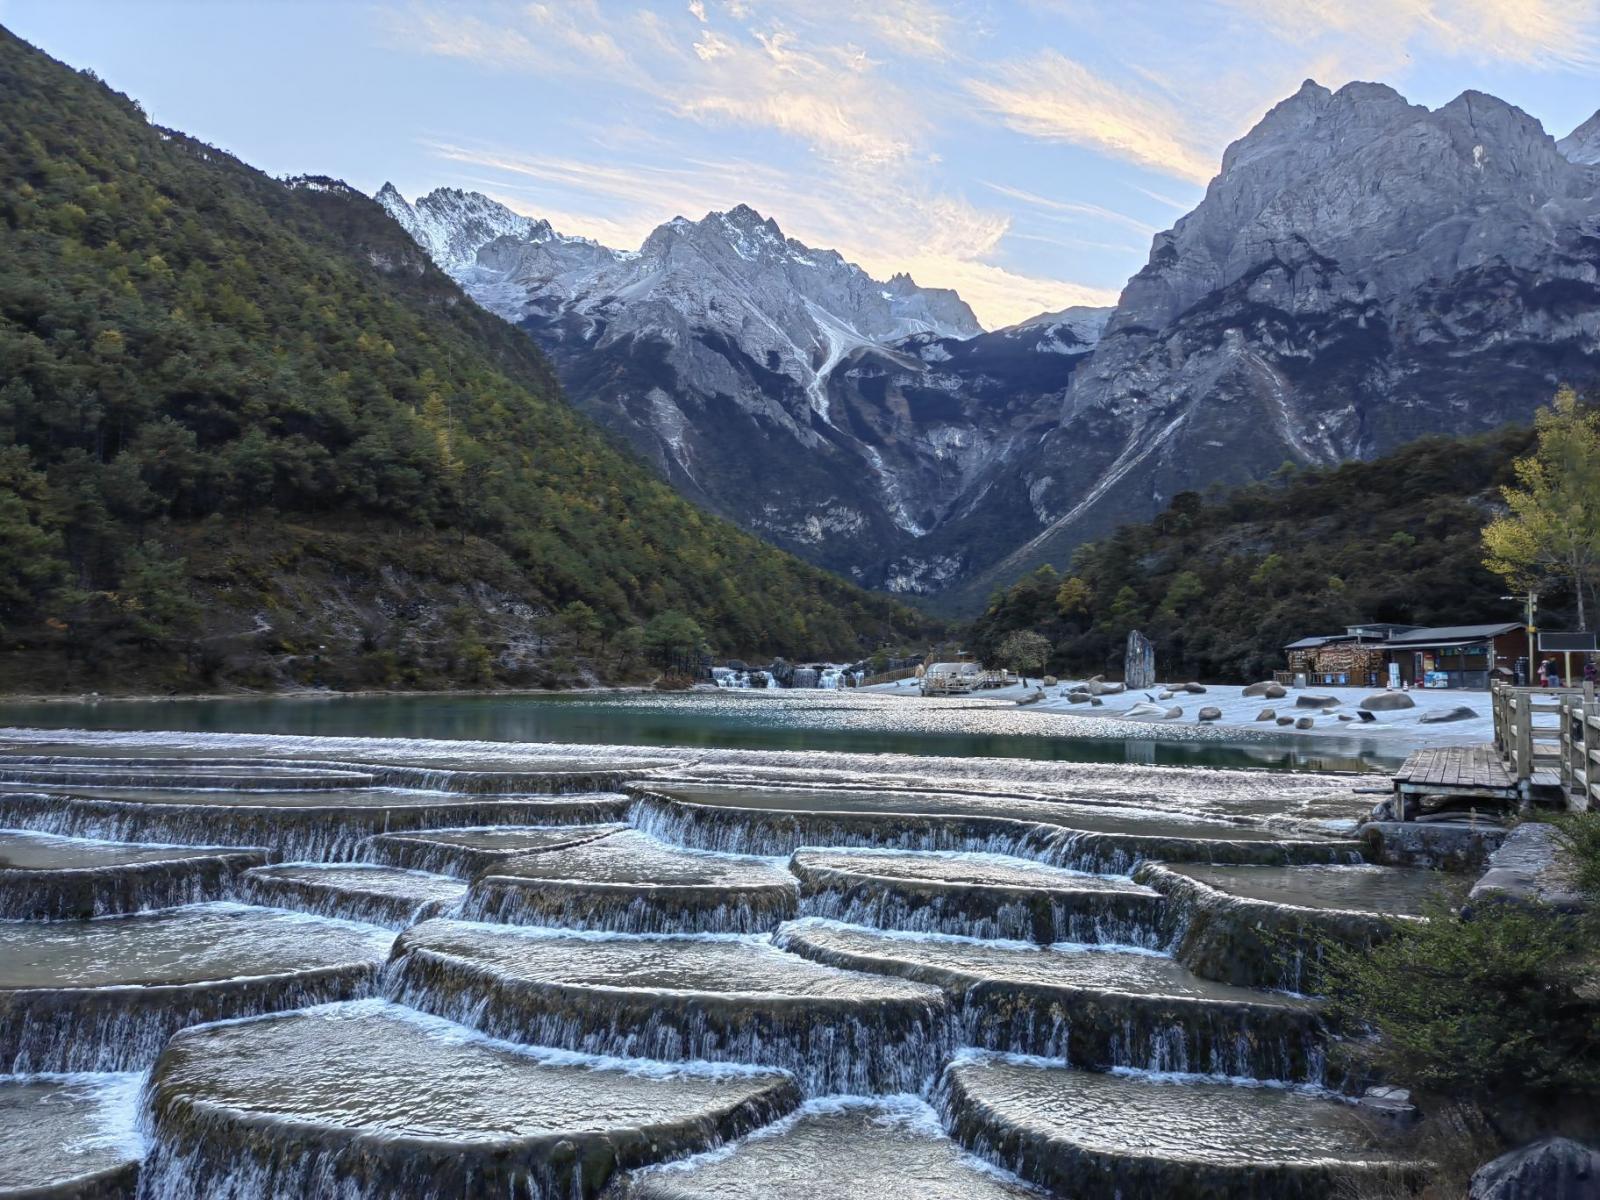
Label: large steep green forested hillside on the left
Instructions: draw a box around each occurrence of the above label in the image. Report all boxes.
[0,30,917,688]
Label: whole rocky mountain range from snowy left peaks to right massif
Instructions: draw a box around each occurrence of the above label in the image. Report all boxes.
[379,82,1600,605]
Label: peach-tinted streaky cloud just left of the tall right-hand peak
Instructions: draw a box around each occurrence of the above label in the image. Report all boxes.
[966,50,1218,184]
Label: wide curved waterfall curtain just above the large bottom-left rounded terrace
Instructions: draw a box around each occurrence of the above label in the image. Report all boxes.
[384,949,955,1096]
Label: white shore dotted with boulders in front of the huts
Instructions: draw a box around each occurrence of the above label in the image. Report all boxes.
[866,680,1494,750]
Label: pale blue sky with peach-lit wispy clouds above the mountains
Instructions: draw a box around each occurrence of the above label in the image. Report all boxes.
[0,0,1600,328]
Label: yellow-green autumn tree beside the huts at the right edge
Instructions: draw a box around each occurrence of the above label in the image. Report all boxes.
[1483,387,1600,629]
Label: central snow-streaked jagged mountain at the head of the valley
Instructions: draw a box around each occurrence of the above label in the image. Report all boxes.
[378,186,1096,592]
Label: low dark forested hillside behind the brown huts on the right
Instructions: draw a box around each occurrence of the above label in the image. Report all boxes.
[971,422,1568,680]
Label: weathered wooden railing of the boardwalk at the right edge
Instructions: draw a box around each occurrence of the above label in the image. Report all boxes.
[1491,683,1600,808]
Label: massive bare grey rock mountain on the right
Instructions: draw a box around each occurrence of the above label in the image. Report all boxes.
[950,82,1600,603]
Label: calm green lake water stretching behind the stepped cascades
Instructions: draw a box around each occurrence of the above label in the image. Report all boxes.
[0,691,1405,771]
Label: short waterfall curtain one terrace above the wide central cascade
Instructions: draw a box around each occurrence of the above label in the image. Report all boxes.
[461,875,798,933]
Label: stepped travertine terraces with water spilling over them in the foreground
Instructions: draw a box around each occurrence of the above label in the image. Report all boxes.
[0,734,1430,1200]
